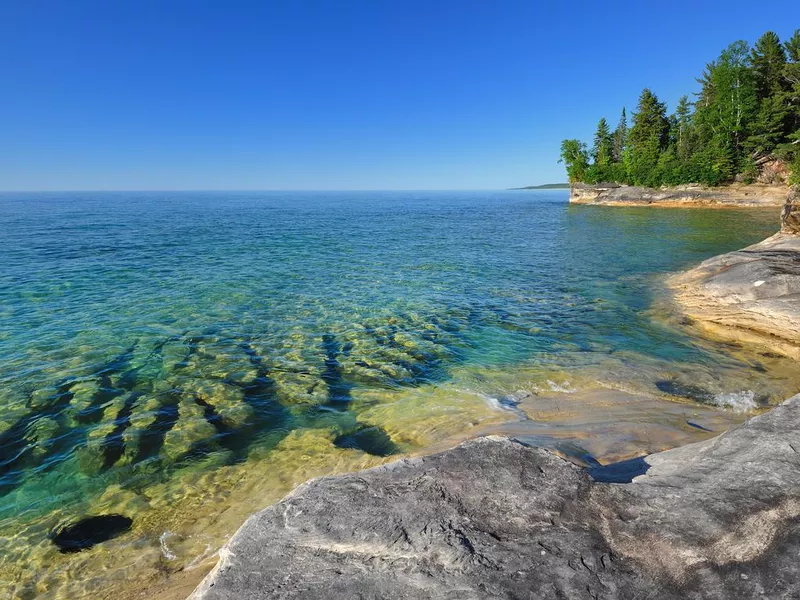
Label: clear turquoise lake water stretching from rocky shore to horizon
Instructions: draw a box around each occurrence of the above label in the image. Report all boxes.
[0,191,797,597]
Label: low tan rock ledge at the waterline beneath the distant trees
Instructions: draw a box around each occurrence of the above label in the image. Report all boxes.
[570,183,786,207]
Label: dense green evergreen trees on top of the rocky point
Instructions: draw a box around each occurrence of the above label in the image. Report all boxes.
[559,30,800,187]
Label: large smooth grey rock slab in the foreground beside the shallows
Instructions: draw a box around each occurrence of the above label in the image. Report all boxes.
[192,395,800,600]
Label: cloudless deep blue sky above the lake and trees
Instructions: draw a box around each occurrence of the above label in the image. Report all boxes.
[0,0,800,190]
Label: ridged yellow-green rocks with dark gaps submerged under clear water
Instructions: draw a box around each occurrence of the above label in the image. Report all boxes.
[0,311,466,497]
